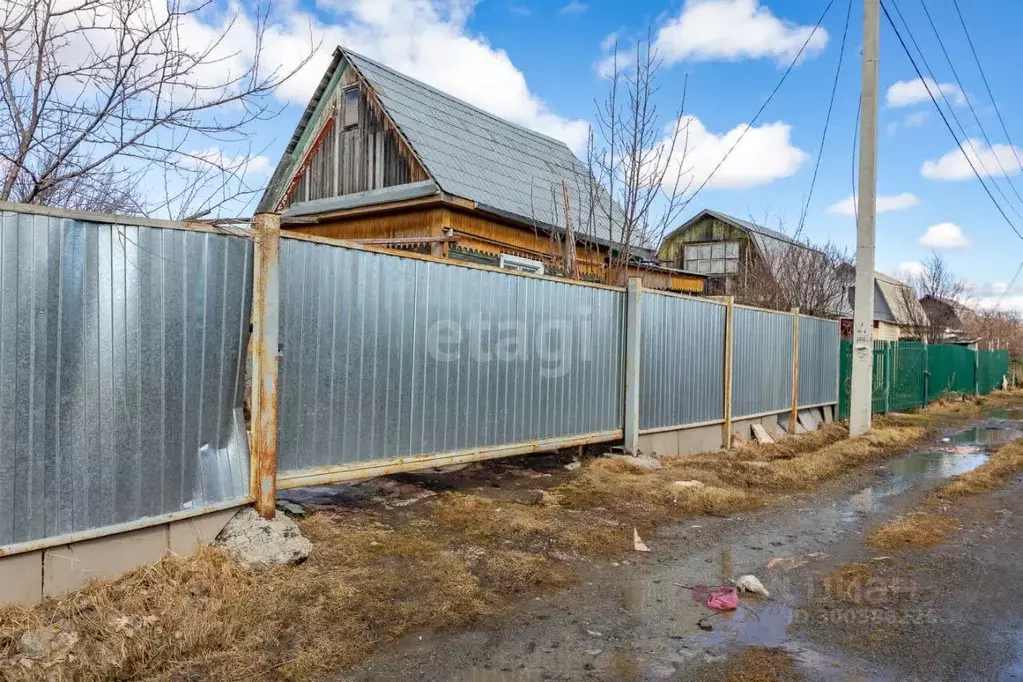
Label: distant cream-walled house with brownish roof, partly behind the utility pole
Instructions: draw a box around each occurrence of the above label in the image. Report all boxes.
[842,266,928,340]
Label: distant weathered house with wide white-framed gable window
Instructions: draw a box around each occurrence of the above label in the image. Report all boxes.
[658,209,813,294]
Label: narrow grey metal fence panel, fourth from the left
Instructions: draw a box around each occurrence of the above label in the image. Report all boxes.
[731,306,795,419]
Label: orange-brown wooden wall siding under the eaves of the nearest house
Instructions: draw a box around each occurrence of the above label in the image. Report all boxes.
[288,206,704,293]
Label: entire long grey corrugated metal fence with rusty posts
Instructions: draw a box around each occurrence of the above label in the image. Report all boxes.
[0,204,838,555]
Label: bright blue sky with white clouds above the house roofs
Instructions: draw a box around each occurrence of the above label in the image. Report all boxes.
[180,0,1023,311]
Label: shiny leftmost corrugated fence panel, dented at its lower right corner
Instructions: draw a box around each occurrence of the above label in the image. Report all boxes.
[0,212,252,546]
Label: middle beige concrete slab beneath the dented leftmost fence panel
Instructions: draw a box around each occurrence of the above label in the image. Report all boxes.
[43,524,167,597]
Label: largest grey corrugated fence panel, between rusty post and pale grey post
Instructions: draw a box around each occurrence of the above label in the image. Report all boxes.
[277,238,625,470]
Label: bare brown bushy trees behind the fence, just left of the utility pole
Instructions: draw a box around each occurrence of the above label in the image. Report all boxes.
[732,226,852,318]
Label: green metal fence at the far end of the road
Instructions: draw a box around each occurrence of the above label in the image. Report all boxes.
[838,339,1009,419]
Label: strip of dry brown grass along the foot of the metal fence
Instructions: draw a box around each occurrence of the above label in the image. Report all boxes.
[0,423,937,680]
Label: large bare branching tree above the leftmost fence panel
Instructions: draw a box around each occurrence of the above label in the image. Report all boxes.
[0,0,313,218]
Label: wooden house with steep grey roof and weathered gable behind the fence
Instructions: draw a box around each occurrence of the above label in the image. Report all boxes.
[258,47,705,293]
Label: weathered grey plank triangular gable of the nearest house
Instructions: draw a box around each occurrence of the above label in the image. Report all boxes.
[282,69,429,208]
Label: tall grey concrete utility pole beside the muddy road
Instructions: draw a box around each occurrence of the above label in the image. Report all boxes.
[849,0,881,436]
